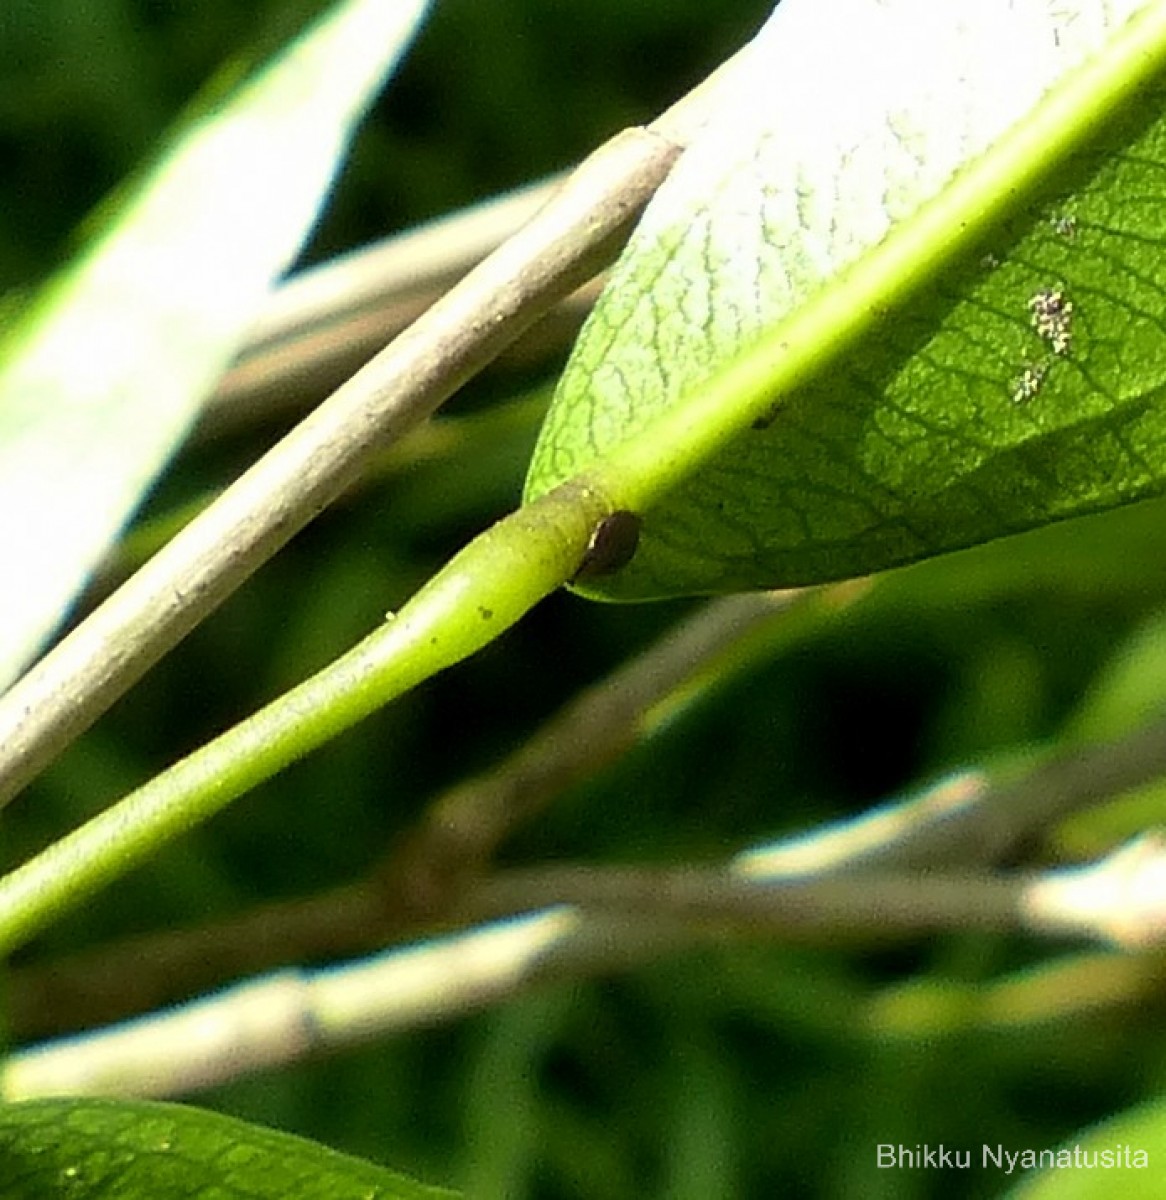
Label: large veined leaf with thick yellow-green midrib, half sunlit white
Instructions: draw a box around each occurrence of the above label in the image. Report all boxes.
[528,0,1166,600]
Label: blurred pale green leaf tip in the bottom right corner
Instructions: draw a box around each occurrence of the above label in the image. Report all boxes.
[1008,1100,1166,1200]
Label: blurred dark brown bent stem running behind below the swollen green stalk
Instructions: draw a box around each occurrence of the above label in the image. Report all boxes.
[8,588,820,1039]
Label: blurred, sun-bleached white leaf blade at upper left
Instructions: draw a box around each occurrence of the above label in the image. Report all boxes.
[0,0,426,688]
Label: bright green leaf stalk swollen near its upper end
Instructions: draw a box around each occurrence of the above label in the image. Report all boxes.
[0,480,612,953]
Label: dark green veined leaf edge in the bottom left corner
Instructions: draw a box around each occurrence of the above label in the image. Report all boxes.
[0,1099,455,1200]
